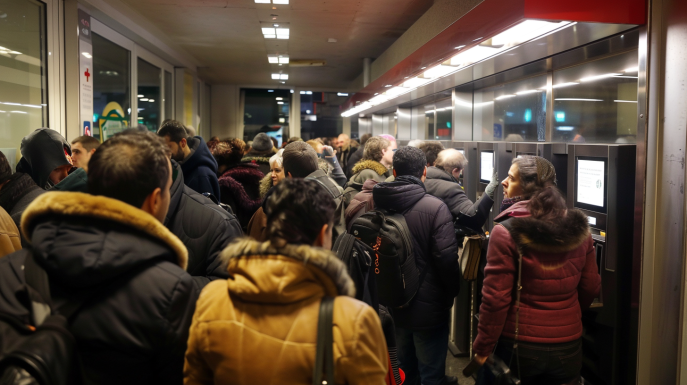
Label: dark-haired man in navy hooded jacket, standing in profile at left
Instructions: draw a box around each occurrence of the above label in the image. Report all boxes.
[157,120,222,199]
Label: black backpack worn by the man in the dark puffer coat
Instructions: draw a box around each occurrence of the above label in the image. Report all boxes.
[351,209,427,308]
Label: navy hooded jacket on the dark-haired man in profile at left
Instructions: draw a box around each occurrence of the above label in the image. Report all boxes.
[179,136,222,199]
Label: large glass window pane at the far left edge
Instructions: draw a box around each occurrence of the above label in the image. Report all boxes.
[0,0,48,167]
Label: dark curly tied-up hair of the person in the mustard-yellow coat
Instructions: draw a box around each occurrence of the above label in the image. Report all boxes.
[265,178,336,247]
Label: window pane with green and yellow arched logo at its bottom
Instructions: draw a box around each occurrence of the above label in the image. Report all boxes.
[92,33,131,140]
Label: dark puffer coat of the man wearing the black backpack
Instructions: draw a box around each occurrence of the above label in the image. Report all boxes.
[372,176,460,330]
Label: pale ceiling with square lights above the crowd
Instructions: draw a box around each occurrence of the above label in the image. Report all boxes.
[117,0,434,90]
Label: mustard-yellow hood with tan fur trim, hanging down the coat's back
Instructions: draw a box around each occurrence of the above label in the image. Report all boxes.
[221,238,355,303]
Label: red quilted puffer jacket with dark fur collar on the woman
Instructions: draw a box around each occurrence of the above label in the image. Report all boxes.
[473,201,601,356]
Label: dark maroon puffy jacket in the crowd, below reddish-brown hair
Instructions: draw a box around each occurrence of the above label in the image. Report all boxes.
[219,163,265,229]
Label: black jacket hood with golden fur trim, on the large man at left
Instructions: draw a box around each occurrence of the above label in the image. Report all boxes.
[21,192,188,287]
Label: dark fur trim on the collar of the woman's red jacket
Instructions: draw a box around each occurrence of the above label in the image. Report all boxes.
[502,209,589,253]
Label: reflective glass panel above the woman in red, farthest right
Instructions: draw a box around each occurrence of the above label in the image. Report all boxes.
[553,50,638,143]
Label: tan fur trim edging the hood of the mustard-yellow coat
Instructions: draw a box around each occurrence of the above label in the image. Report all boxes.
[220,238,355,297]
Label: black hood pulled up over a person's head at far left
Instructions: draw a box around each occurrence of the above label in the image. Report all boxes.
[17,128,72,189]
